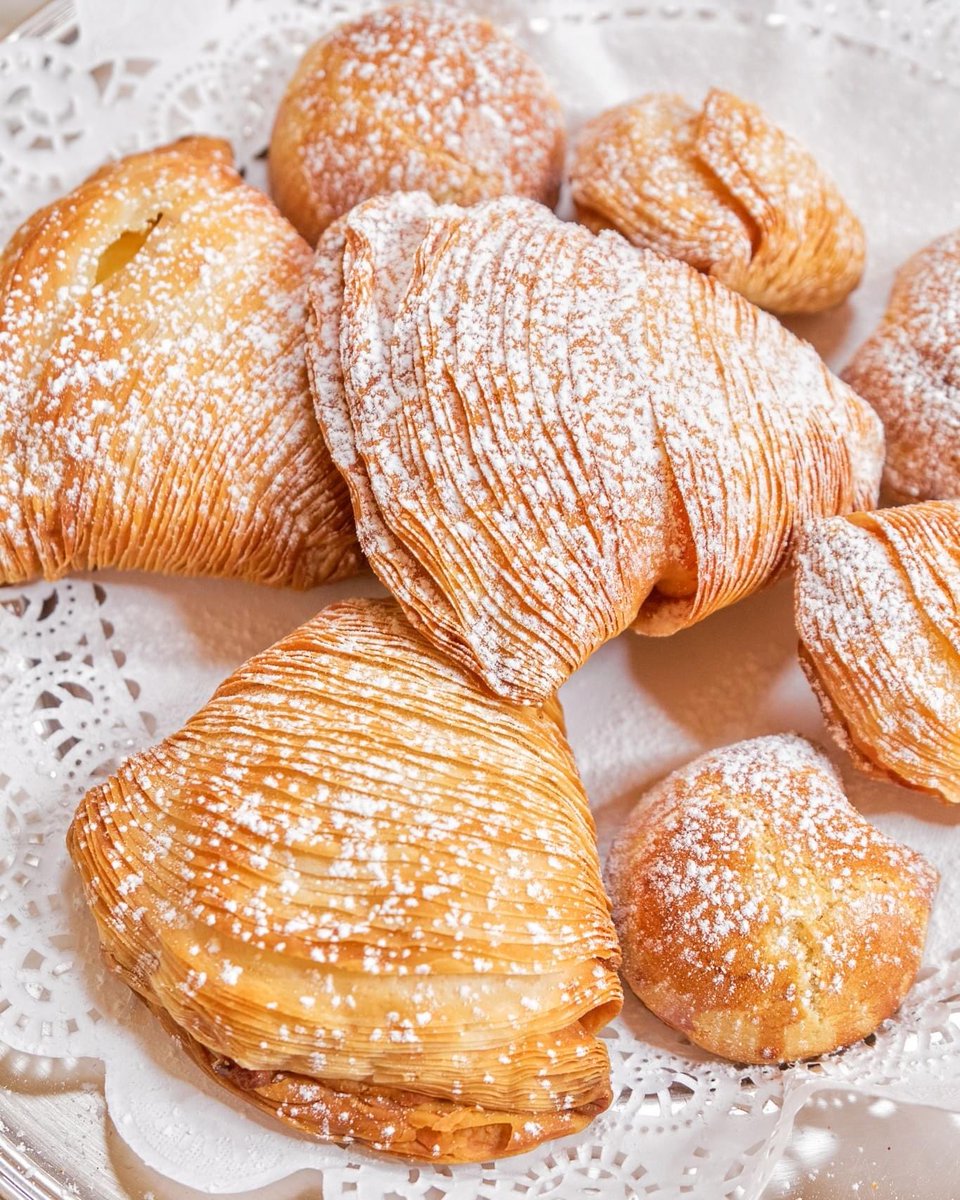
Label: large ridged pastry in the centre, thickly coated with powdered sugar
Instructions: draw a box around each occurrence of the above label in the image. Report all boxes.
[308,193,882,702]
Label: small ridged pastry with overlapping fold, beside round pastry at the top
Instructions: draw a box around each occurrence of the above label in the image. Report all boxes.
[571,89,864,313]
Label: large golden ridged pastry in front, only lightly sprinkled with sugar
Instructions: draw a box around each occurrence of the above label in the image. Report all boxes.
[68,600,622,1162]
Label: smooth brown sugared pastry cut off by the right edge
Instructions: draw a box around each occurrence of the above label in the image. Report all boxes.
[844,229,960,500]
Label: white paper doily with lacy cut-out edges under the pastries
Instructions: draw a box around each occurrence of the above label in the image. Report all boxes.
[0,0,960,1200]
